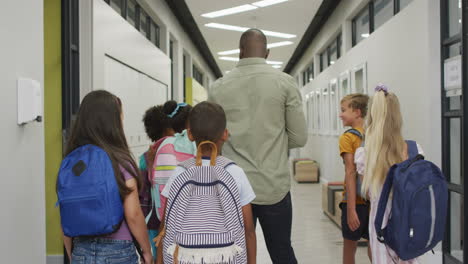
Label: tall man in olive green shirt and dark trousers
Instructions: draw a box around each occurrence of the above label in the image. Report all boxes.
[208,29,307,264]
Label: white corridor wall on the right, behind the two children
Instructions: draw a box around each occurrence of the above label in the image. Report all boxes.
[292,0,441,181]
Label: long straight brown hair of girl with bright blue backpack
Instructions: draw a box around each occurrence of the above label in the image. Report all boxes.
[65,90,141,199]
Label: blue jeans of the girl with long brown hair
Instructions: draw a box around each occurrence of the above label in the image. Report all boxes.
[71,238,138,264]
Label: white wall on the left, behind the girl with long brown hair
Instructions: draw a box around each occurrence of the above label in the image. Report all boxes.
[92,0,171,157]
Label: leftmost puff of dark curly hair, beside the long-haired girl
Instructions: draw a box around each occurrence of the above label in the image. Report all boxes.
[143,105,171,142]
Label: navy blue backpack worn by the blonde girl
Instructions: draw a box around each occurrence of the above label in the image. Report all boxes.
[375,141,448,260]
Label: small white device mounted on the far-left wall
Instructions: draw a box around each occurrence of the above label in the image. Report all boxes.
[17,78,42,125]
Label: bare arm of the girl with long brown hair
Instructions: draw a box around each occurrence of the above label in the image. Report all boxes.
[124,179,153,264]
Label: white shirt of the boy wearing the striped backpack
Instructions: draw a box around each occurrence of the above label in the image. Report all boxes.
[161,159,255,206]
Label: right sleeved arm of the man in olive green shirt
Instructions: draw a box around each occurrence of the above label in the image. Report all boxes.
[285,78,307,149]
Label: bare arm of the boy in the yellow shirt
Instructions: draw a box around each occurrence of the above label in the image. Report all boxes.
[343,153,360,231]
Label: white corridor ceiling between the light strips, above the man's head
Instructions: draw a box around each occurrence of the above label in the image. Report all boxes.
[185,0,322,74]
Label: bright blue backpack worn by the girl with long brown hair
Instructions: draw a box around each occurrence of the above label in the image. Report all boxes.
[57,145,124,237]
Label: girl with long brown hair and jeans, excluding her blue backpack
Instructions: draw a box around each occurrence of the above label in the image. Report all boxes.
[64,91,152,263]
